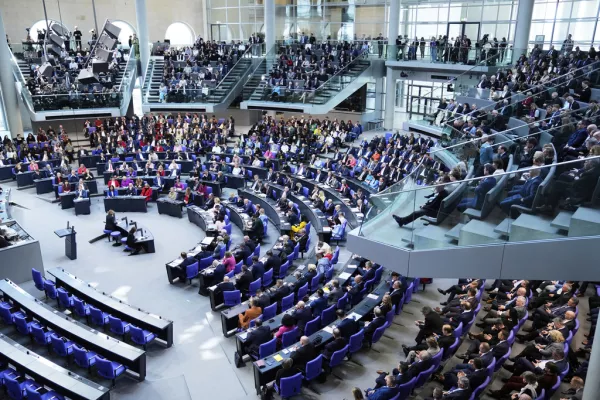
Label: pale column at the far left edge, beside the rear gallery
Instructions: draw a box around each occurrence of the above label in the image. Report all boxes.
[0,14,27,138]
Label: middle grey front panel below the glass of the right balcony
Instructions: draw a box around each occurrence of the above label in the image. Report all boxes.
[408,244,504,279]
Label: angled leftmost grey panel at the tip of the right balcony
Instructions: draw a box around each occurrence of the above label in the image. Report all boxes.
[347,234,410,275]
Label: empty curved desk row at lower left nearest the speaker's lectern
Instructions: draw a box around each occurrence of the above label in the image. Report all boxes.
[46,268,173,347]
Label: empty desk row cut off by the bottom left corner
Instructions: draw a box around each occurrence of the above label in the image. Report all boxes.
[0,334,110,400]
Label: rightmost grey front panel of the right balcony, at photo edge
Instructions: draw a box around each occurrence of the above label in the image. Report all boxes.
[501,237,600,281]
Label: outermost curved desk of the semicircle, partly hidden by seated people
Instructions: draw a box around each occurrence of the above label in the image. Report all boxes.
[252,271,390,394]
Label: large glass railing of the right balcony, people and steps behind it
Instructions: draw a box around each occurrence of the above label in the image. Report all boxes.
[359,155,600,250]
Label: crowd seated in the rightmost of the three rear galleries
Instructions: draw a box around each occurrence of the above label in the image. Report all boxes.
[263,36,368,102]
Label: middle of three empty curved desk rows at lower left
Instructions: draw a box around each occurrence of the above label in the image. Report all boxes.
[0,279,146,381]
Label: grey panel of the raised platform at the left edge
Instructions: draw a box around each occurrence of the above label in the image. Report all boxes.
[0,240,44,283]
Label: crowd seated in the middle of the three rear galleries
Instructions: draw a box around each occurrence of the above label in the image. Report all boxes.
[159,37,249,102]
